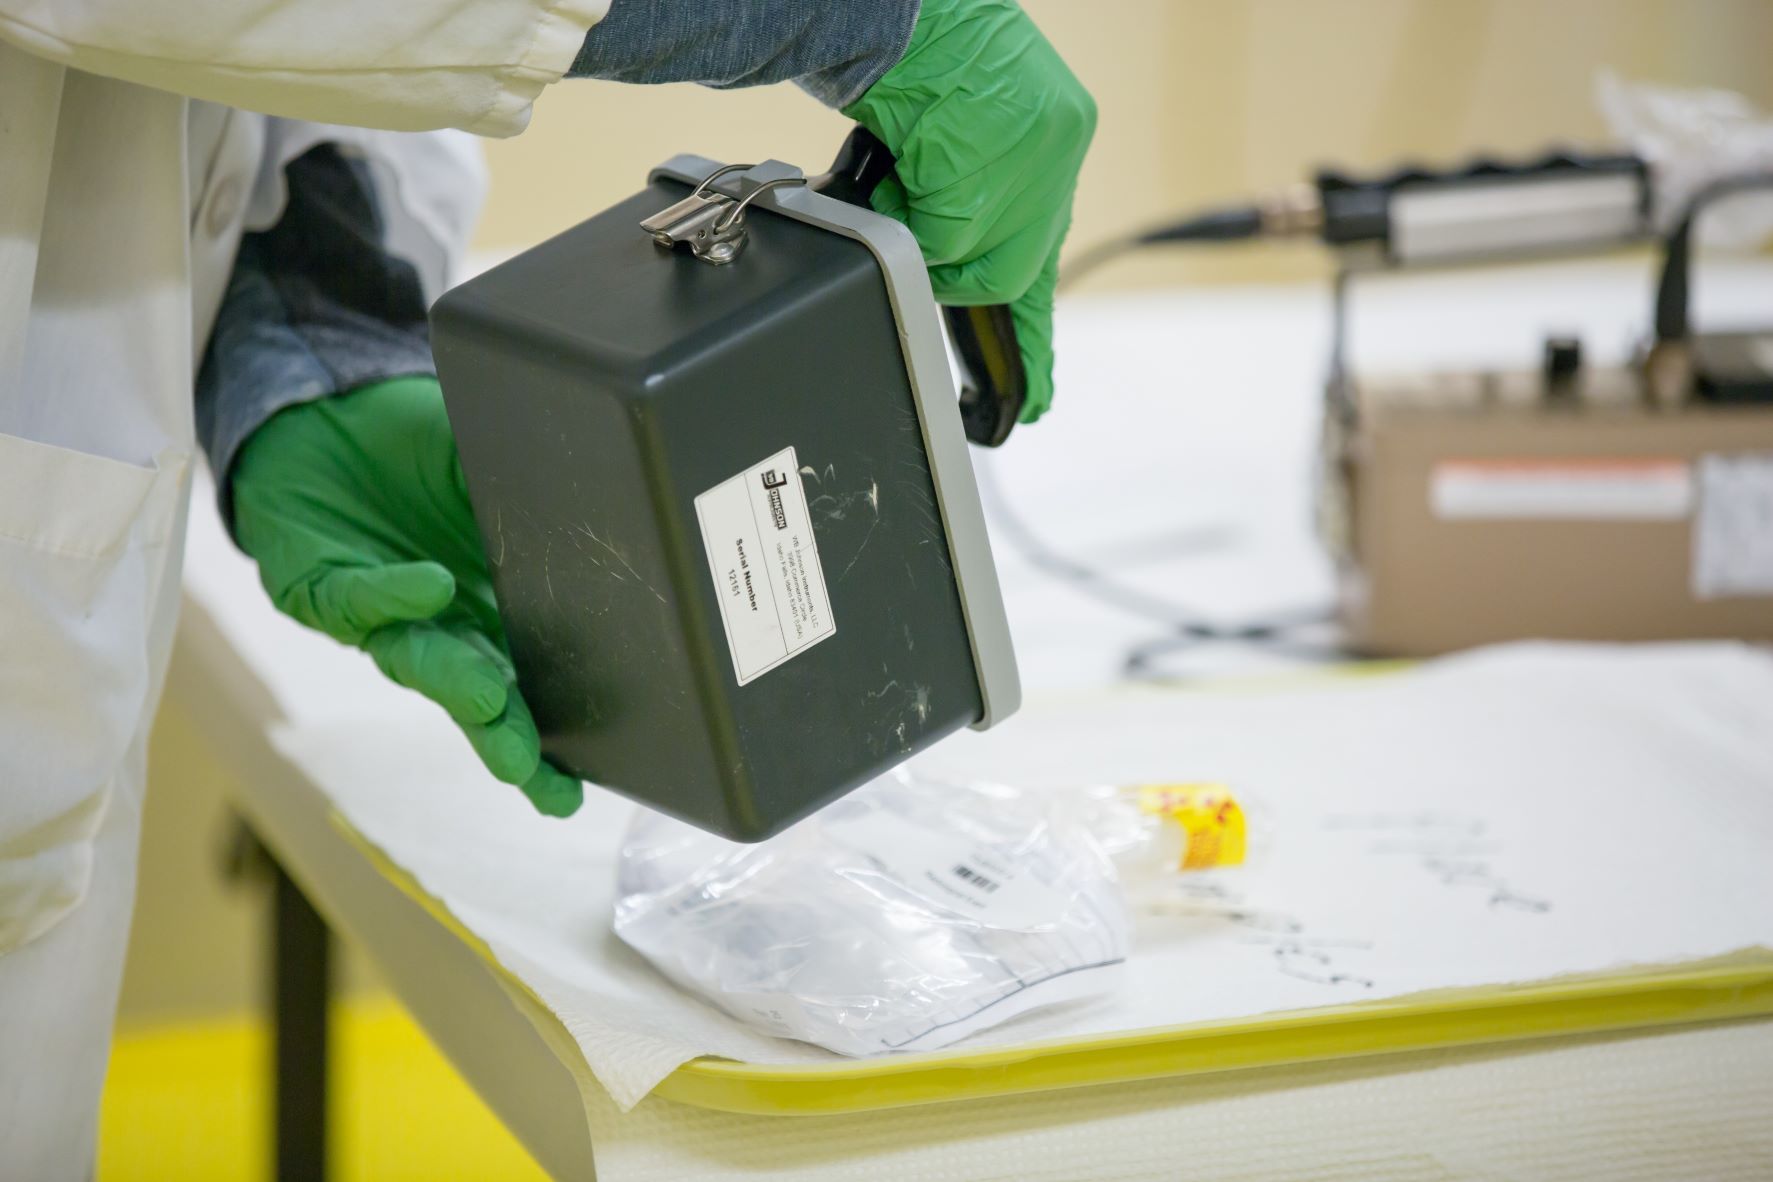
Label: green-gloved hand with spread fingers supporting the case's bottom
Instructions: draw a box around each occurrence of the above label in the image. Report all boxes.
[232,377,583,817]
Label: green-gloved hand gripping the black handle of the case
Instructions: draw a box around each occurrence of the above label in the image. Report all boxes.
[844,0,1096,422]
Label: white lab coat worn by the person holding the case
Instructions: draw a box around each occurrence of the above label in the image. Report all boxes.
[0,0,608,1182]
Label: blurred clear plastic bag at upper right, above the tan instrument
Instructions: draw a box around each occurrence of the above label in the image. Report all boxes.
[1596,71,1773,250]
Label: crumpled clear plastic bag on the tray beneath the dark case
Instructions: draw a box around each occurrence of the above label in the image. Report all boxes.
[615,769,1129,1056]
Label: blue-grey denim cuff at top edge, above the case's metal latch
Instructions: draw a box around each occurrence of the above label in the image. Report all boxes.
[571,0,918,106]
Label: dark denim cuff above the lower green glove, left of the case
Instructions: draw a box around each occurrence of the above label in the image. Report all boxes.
[197,144,436,521]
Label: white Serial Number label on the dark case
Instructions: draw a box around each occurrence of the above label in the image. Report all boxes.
[695,447,837,686]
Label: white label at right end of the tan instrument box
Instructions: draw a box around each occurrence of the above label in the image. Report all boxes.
[1693,452,1773,599]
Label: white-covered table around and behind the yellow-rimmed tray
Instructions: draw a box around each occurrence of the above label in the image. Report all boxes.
[168,262,1773,1180]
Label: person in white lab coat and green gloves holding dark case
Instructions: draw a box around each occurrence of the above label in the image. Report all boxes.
[0,0,1094,1182]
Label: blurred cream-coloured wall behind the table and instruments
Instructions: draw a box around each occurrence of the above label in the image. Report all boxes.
[124,0,1773,1019]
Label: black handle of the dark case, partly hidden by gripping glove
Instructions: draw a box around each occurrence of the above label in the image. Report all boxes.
[807,126,1028,447]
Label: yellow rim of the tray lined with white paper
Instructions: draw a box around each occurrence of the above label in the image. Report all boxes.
[342,812,1773,1116]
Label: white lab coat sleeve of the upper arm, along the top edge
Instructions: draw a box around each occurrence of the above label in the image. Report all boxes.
[0,0,610,136]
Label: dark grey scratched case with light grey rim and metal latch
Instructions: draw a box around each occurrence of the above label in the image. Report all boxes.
[431,158,1019,840]
